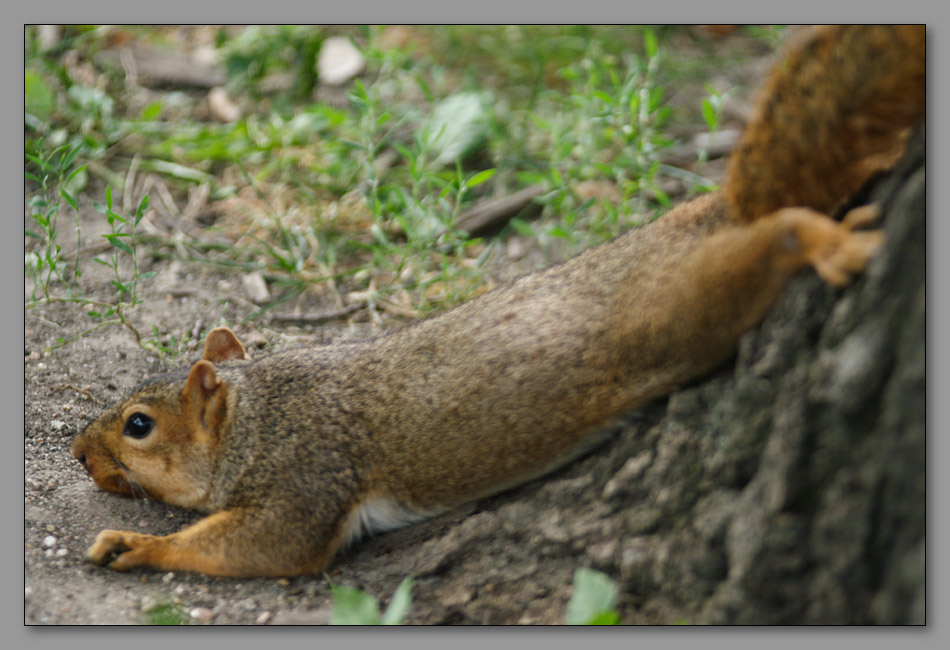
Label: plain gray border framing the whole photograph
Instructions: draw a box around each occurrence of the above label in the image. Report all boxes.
[7,0,950,650]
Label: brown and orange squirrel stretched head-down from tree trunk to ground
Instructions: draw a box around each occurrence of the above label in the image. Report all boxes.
[71,25,926,577]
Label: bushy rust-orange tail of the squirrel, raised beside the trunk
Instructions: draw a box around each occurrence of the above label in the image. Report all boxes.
[726,25,926,222]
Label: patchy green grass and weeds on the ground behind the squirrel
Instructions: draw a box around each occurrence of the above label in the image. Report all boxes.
[24,26,773,344]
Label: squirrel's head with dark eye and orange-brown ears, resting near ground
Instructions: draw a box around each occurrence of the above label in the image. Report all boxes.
[72,327,247,508]
